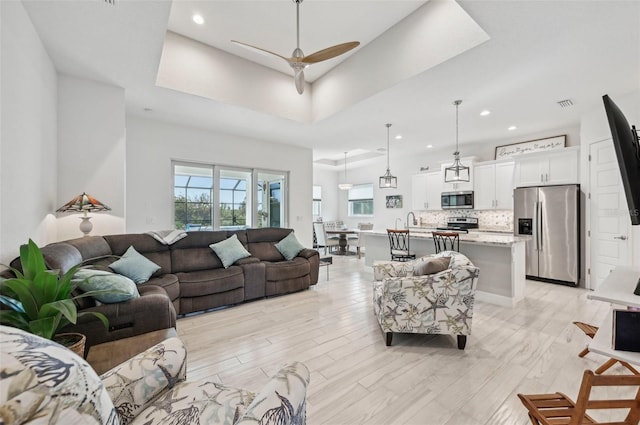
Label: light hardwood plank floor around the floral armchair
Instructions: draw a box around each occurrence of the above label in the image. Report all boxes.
[177,256,627,425]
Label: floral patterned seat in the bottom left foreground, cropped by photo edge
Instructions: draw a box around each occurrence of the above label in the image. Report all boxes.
[0,326,309,425]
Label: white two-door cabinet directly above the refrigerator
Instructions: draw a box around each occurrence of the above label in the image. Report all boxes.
[514,146,580,187]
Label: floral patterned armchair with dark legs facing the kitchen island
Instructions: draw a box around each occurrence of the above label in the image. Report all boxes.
[373,251,479,350]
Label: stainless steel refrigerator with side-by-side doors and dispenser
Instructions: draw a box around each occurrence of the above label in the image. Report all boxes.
[513,185,580,286]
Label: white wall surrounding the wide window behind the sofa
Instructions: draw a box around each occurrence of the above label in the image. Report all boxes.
[126,115,313,246]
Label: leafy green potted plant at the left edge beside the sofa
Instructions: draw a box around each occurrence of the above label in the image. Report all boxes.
[0,239,109,355]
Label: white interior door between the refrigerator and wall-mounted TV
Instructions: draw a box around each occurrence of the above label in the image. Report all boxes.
[588,140,631,290]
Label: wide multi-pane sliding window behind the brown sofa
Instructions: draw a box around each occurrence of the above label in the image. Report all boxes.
[173,162,288,231]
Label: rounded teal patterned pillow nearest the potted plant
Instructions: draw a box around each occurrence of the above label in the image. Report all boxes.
[71,269,140,304]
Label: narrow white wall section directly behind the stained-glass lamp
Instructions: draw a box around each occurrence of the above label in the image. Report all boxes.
[54,75,126,240]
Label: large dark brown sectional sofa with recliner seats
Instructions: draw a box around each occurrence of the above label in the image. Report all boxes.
[12,228,320,349]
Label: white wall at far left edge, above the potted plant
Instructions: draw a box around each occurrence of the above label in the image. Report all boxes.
[0,1,57,264]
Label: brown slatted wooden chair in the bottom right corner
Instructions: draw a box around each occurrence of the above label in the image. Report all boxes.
[518,370,640,425]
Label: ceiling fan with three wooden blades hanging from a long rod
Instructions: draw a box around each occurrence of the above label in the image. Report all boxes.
[231,0,360,94]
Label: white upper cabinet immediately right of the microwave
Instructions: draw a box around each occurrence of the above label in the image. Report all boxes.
[473,161,515,210]
